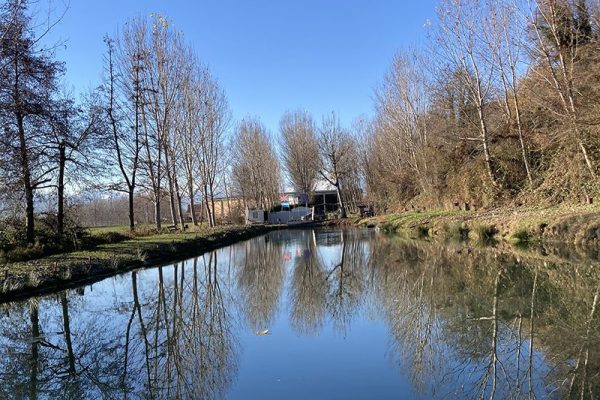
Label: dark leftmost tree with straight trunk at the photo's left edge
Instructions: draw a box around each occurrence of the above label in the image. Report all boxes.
[0,0,62,243]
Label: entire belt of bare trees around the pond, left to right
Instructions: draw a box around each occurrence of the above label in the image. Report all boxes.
[0,0,600,249]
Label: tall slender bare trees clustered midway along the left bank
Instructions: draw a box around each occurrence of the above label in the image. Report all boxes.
[102,16,230,229]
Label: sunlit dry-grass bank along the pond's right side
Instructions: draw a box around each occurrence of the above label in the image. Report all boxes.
[358,206,600,245]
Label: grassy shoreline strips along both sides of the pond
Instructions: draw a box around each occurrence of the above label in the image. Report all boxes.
[0,206,600,304]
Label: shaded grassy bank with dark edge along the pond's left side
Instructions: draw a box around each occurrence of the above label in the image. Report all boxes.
[0,226,274,302]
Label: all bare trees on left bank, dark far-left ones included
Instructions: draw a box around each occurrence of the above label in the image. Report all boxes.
[0,0,230,248]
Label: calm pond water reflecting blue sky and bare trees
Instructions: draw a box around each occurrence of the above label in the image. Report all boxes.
[0,230,600,399]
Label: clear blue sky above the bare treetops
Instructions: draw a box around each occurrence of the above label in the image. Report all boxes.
[39,0,435,133]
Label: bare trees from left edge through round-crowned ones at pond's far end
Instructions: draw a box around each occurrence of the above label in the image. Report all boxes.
[0,0,360,250]
